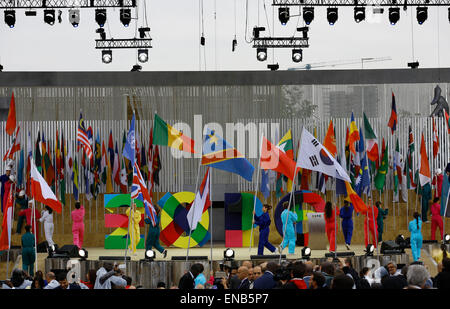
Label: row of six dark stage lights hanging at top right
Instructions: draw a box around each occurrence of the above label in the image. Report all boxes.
[278,6,432,26]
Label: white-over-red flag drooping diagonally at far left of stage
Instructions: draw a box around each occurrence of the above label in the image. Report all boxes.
[31,160,62,213]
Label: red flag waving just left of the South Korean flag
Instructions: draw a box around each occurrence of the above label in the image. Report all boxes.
[259,137,296,180]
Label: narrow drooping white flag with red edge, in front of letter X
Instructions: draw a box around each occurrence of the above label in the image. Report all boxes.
[187,168,211,231]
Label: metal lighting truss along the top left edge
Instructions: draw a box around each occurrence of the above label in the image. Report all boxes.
[0,0,136,9]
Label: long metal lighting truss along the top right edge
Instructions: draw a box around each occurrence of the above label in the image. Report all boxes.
[272,0,450,7]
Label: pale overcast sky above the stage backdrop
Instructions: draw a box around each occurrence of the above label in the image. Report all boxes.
[0,0,450,71]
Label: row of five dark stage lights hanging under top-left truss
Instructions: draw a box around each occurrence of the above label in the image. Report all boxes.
[4,9,132,28]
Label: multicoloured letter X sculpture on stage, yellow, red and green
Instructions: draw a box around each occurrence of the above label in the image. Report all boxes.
[158,192,211,249]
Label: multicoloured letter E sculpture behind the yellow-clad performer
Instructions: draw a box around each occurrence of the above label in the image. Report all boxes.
[104,194,145,249]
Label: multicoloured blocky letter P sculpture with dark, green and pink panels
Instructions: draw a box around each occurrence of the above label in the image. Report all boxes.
[225,193,262,248]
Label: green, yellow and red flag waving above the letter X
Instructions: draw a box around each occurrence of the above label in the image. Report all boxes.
[153,114,195,153]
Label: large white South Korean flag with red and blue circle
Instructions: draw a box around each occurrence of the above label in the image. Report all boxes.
[297,128,351,182]
